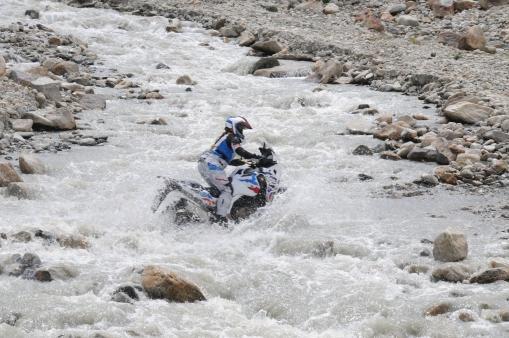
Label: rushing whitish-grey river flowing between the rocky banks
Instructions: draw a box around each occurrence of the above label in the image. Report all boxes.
[0,0,509,337]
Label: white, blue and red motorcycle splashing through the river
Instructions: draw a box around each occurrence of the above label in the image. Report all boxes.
[152,144,283,225]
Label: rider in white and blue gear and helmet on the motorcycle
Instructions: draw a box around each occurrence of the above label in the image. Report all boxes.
[198,116,261,221]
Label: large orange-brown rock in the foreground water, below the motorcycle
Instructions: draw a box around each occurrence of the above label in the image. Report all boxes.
[142,266,206,303]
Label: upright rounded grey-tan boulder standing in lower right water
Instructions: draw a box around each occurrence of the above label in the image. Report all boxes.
[433,231,468,262]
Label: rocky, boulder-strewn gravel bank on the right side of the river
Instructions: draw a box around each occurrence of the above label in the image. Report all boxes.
[62,0,509,186]
